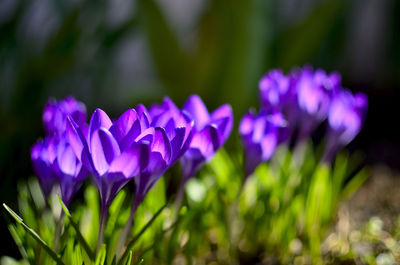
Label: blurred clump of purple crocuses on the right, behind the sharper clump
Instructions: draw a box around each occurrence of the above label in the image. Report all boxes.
[239,66,368,175]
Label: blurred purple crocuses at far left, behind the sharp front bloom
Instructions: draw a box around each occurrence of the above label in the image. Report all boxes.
[31,97,88,205]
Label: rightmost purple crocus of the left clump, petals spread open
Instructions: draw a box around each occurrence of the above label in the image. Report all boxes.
[181,95,233,183]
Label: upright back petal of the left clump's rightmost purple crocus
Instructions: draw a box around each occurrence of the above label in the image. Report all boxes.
[183,95,210,130]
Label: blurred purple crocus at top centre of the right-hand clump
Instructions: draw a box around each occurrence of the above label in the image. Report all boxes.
[291,66,341,140]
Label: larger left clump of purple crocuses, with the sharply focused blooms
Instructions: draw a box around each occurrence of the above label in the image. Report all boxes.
[31,95,233,248]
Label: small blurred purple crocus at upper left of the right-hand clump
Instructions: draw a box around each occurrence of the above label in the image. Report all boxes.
[258,69,290,110]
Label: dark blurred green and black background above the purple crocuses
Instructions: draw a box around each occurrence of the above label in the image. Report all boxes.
[0,0,400,256]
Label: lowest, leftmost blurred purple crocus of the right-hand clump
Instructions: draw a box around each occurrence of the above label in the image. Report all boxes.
[239,112,287,176]
